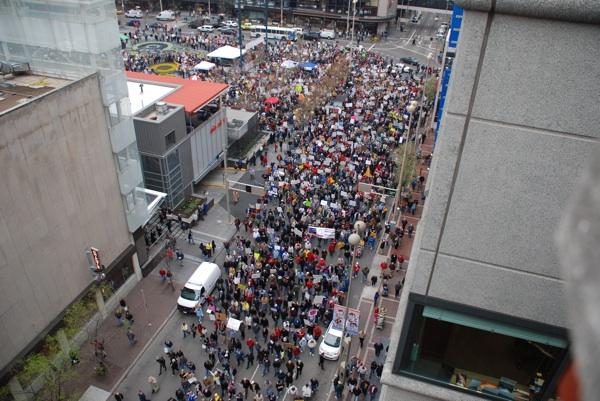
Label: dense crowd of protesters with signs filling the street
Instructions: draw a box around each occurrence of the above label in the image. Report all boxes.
[120,25,426,401]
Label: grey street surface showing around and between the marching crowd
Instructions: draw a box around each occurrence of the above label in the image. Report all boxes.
[106,6,440,401]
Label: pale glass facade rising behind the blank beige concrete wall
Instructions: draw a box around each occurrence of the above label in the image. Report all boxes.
[0,0,157,232]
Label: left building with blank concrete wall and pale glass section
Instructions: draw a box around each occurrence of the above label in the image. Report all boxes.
[0,0,163,371]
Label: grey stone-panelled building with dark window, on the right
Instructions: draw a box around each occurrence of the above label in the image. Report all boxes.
[380,0,600,401]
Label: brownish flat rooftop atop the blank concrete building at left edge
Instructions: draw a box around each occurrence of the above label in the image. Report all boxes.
[0,74,72,115]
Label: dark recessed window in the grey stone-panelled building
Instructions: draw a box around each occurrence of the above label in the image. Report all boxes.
[394,294,568,401]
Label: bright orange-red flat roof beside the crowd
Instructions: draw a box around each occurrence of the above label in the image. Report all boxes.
[126,71,229,113]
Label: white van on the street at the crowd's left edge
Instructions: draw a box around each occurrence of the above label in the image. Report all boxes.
[177,262,221,313]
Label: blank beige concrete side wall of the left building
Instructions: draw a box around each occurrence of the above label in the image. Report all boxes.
[0,74,133,367]
